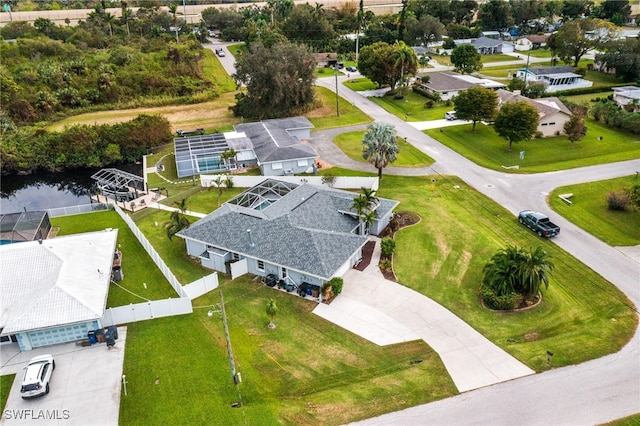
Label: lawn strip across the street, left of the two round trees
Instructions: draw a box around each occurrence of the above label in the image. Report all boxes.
[369,90,453,121]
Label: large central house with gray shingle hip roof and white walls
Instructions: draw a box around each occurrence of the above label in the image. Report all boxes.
[176,179,398,285]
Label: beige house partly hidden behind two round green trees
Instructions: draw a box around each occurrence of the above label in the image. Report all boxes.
[496,90,571,137]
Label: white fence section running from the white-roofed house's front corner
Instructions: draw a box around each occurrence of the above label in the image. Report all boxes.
[102,297,193,327]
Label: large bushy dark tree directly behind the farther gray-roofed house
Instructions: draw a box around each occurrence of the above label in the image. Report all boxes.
[231,42,316,119]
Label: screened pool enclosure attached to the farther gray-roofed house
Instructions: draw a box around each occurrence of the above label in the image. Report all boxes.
[173,133,234,178]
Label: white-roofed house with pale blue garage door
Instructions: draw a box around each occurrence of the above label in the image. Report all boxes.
[0,230,118,351]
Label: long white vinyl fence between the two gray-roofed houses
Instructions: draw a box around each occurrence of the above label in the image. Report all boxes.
[200,175,379,190]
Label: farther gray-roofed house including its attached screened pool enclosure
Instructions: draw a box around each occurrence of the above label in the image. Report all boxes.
[173,117,318,178]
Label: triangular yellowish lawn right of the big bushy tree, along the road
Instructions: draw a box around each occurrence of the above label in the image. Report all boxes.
[305,86,371,130]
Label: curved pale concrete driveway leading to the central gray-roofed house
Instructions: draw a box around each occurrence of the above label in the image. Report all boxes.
[313,269,535,392]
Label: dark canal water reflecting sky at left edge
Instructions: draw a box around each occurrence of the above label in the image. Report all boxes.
[0,164,142,214]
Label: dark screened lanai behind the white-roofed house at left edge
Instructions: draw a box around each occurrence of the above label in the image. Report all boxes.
[0,211,51,244]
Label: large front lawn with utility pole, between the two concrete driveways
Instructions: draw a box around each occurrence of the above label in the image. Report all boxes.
[120,276,456,425]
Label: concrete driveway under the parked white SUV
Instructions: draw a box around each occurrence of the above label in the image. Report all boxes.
[0,327,127,426]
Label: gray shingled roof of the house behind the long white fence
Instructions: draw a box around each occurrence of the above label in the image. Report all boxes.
[235,117,318,163]
